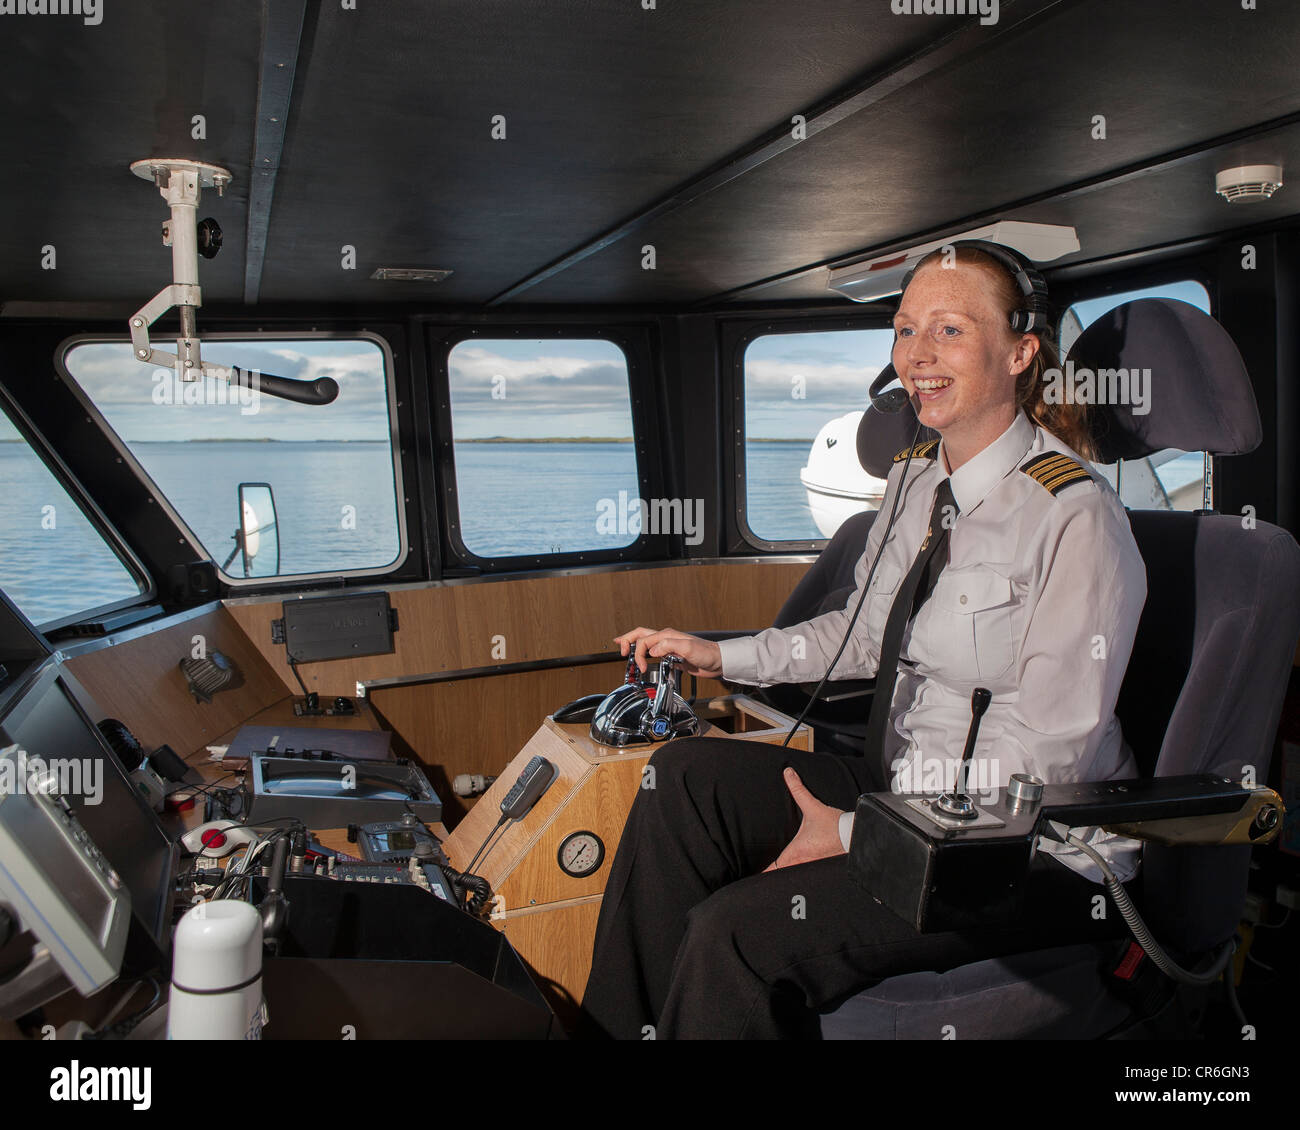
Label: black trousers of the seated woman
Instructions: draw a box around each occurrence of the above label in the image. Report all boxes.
[582,737,1125,1039]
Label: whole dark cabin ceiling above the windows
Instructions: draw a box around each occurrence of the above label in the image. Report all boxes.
[0,0,1300,307]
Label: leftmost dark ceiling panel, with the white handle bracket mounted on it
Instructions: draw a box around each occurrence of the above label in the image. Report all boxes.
[0,0,261,306]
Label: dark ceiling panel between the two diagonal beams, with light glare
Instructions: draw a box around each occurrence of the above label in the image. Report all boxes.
[527,0,1300,303]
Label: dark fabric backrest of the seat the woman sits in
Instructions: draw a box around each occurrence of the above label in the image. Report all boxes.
[1115,511,1300,952]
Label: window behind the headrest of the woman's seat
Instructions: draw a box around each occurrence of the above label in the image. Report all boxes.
[1061,281,1210,510]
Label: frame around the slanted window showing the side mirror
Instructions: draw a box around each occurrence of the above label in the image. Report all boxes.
[55,329,412,592]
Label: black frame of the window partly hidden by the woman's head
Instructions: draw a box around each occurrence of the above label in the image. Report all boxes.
[720,310,897,554]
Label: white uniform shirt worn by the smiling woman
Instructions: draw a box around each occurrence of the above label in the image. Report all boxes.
[720,412,1147,882]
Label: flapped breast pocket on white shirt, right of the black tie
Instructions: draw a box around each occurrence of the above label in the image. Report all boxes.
[932,568,1017,681]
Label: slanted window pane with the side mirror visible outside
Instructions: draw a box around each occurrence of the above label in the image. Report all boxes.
[64,337,404,583]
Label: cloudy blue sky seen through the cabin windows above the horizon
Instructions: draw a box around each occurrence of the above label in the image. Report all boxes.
[53,282,1209,442]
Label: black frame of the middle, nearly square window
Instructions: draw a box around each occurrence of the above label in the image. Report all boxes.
[425,322,680,576]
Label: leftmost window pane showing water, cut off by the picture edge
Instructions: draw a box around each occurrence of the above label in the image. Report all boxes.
[0,403,144,627]
